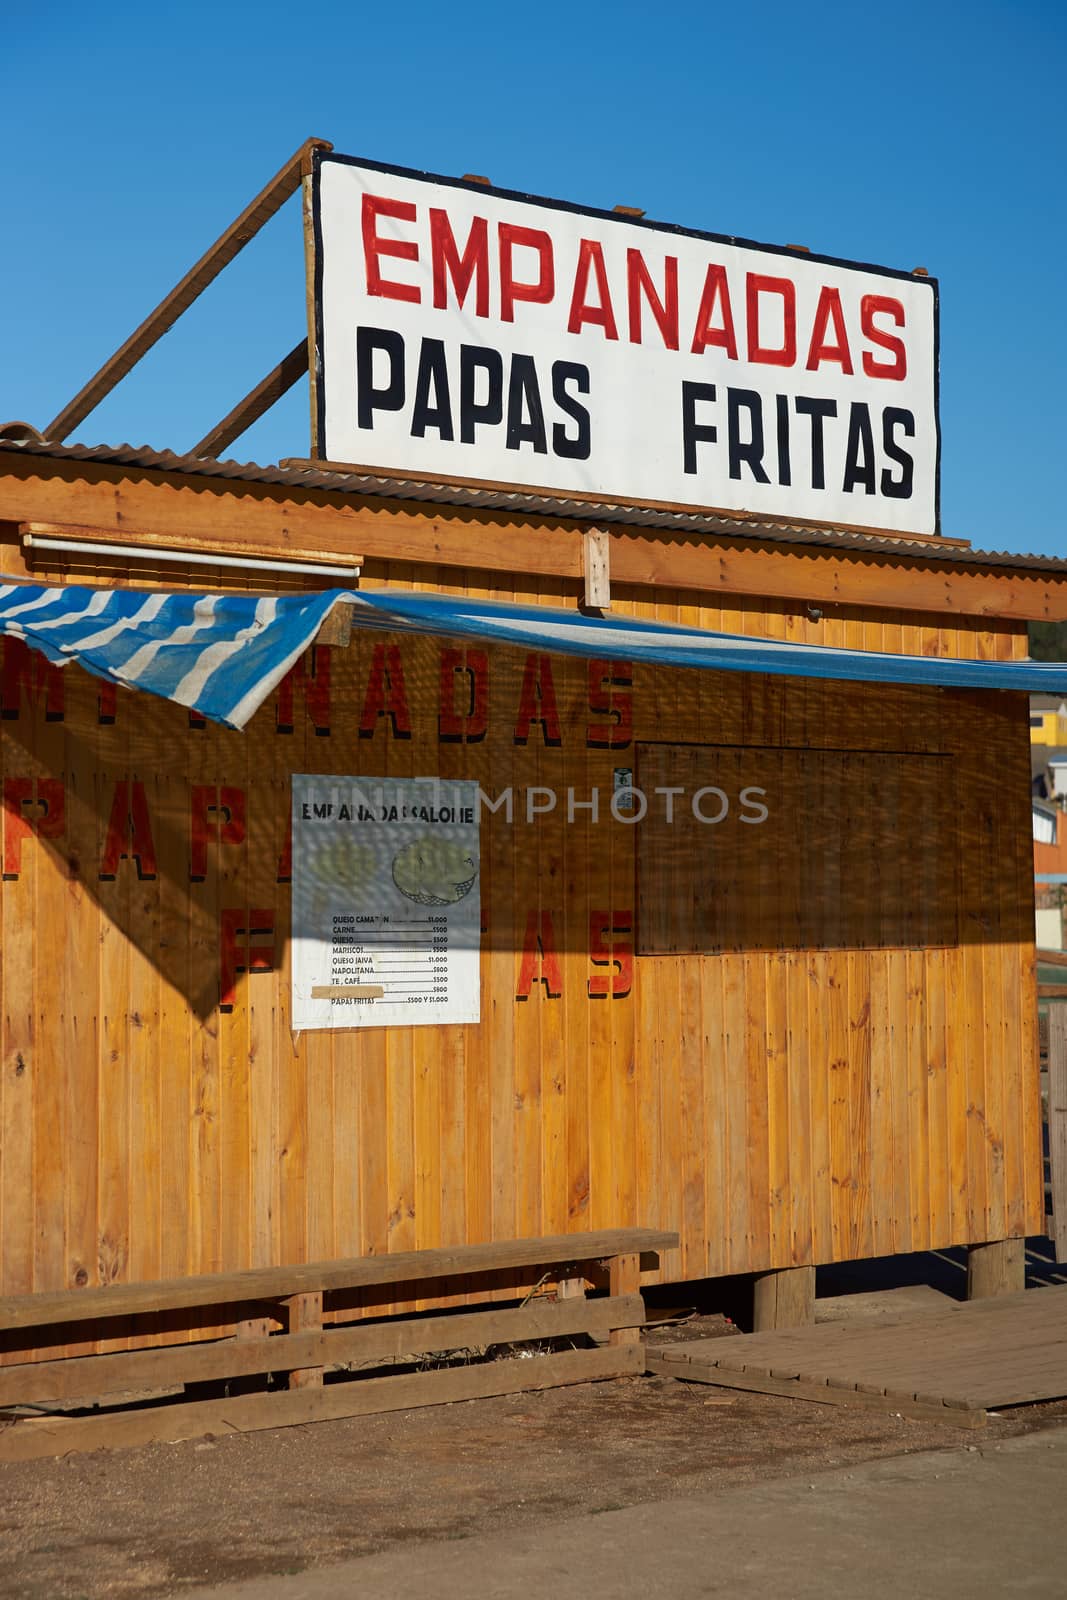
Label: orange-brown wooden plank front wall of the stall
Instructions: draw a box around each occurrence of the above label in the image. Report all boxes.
[0,528,1043,1350]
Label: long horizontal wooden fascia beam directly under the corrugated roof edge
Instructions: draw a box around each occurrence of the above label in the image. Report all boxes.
[0,457,1067,624]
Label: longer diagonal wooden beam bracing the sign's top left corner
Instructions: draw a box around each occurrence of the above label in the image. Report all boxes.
[45,139,333,438]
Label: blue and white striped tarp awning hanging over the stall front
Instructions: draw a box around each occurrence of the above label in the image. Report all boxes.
[0,584,1067,728]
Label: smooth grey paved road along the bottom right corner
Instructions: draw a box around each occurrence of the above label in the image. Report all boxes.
[186,1427,1067,1600]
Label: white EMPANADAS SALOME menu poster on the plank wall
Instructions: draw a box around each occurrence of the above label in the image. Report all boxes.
[293,773,482,1030]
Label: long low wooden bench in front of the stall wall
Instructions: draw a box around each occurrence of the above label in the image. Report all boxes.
[0,1227,678,1461]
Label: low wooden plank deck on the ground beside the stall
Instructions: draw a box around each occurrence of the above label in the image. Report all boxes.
[648,1285,1067,1427]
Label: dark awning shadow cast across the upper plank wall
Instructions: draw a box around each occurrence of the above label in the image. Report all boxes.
[2,638,1032,1021]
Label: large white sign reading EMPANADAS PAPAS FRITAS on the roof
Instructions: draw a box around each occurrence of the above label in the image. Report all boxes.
[314,155,939,533]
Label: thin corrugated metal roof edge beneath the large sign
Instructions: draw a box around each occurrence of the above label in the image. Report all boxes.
[0,440,1067,576]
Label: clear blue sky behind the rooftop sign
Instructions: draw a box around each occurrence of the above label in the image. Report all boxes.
[0,0,1067,555]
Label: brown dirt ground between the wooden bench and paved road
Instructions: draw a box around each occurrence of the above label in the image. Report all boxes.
[0,1315,1067,1600]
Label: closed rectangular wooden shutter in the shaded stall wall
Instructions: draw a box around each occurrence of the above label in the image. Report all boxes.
[635,744,960,955]
